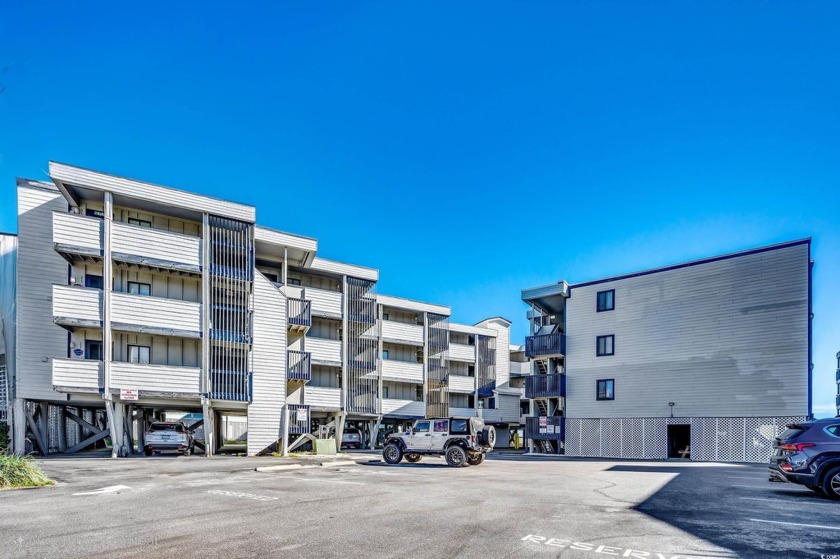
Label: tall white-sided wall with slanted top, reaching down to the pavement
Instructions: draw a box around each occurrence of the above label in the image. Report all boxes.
[248,272,286,455]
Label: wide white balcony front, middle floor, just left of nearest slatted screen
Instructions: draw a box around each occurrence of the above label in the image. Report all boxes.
[111,293,201,338]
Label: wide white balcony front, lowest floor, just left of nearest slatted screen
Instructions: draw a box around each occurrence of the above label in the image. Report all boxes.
[111,361,201,398]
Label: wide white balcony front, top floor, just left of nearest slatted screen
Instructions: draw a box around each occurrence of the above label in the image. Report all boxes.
[111,222,201,275]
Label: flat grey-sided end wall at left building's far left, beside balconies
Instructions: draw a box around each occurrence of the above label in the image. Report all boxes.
[16,184,68,400]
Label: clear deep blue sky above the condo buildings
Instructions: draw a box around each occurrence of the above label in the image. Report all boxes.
[0,1,840,414]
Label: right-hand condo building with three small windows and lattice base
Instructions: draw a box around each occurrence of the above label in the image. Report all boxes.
[522,239,812,461]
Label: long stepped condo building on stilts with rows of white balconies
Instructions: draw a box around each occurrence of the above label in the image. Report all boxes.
[7,163,520,455]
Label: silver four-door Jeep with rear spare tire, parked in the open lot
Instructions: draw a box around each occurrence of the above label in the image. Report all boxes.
[382,417,496,467]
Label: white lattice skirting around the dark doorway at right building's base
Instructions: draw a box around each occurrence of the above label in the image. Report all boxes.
[565,416,805,462]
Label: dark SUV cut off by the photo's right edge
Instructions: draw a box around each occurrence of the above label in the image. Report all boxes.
[770,416,840,499]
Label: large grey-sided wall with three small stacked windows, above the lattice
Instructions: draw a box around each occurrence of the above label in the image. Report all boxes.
[566,244,809,418]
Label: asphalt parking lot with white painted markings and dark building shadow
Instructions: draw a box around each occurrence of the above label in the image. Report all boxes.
[0,454,840,559]
